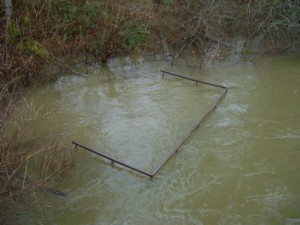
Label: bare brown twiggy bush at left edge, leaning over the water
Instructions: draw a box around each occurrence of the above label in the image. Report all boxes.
[0,86,74,224]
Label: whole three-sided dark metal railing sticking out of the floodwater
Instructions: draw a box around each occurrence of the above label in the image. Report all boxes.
[72,70,228,178]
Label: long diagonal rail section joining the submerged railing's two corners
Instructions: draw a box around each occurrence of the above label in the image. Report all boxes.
[153,87,228,177]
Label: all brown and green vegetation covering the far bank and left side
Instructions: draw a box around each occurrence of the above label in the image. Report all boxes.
[0,0,300,224]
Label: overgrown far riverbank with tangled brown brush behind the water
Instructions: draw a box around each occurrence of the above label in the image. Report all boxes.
[0,0,300,89]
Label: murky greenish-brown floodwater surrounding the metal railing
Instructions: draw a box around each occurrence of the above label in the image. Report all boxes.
[17,57,300,225]
